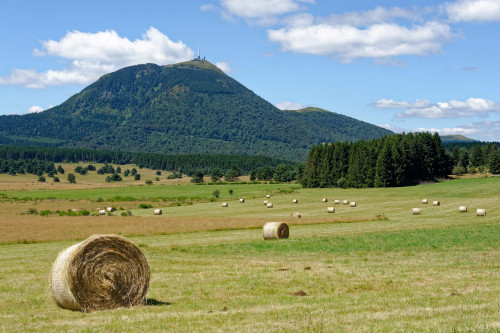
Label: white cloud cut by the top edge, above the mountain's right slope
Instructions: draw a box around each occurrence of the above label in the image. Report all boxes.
[221,0,315,25]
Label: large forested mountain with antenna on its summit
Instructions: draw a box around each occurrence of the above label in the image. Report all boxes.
[0,61,391,160]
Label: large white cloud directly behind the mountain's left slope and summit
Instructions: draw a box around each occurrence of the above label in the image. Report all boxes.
[0,27,194,88]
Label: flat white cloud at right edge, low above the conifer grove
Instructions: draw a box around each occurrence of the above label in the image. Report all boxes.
[372,97,500,118]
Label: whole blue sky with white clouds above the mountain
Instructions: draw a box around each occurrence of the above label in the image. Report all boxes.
[0,0,500,141]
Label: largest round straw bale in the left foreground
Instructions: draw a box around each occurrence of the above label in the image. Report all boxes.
[51,234,150,312]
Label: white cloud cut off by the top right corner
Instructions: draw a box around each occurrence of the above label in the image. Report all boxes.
[444,0,500,22]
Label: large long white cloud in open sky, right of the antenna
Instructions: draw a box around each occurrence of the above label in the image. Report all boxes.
[267,22,453,63]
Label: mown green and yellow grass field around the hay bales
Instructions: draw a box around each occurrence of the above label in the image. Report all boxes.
[0,176,500,332]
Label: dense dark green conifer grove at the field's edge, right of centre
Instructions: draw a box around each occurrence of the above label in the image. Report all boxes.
[300,132,453,188]
